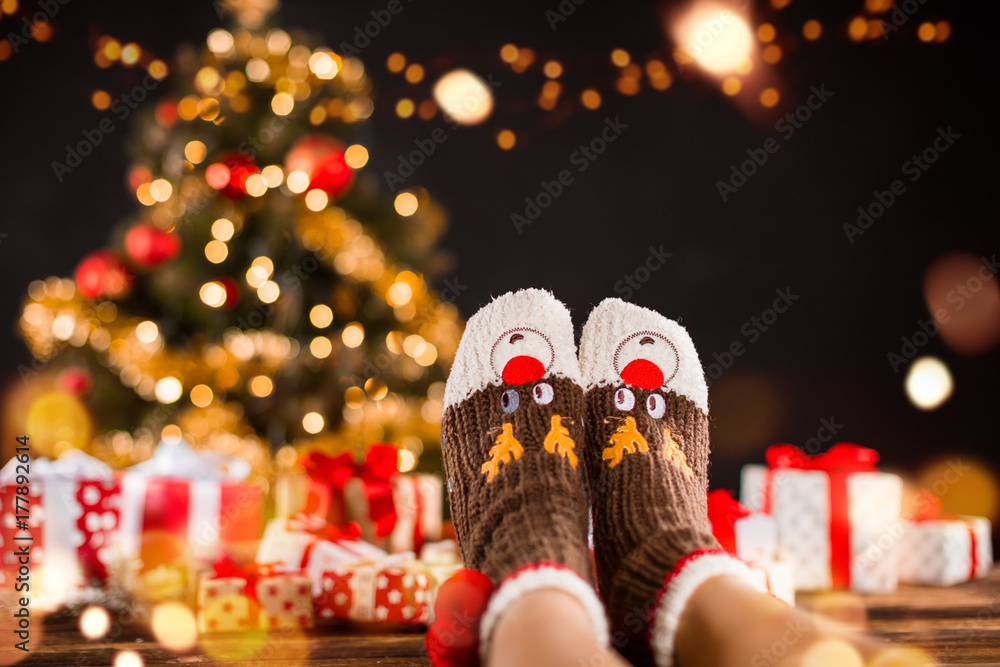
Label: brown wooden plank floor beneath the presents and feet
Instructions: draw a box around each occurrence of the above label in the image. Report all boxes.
[13,569,1000,667]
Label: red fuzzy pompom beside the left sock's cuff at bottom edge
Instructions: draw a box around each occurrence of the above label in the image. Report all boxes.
[426,568,493,667]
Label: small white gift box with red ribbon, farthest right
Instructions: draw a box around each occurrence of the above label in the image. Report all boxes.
[899,492,993,586]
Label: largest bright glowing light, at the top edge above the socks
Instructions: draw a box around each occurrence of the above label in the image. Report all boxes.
[674,0,753,74]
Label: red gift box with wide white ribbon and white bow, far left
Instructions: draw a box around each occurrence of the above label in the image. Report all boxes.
[119,440,264,561]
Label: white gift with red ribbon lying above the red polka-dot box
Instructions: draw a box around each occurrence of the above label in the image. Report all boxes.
[256,514,387,595]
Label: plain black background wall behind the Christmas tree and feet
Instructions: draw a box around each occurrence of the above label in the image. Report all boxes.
[0,0,1000,518]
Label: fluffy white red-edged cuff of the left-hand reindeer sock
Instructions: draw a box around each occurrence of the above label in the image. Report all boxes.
[479,563,610,665]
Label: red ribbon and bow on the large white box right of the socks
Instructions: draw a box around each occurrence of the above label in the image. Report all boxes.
[764,442,878,588]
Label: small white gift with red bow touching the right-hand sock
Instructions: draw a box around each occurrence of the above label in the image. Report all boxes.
[708,489,778,563]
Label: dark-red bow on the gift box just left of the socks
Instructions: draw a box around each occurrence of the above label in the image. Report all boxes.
[301,444,399,537]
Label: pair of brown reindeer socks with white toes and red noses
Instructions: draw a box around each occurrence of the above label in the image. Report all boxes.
[442,290,753,665]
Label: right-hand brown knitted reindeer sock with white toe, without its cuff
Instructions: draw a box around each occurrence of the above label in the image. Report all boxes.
[580,299,745,664]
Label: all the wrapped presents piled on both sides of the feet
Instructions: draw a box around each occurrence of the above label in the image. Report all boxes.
[0,441,993,633]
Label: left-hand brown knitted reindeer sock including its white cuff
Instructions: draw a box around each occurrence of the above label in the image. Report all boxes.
[441,290,607,655]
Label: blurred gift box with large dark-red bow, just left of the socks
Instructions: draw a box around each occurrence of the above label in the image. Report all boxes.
[275,444,443,553]
